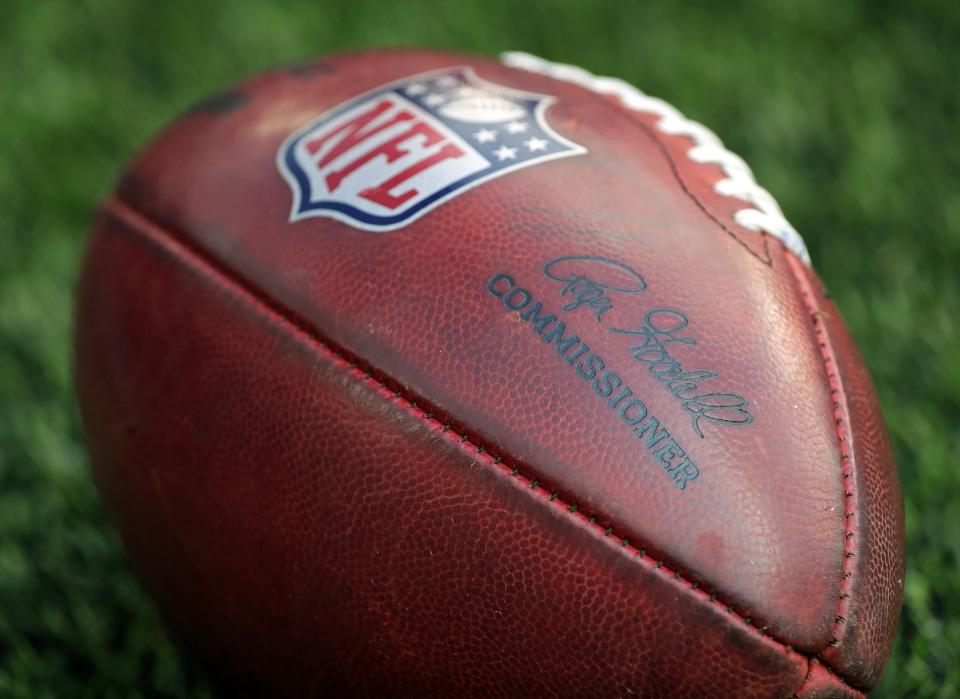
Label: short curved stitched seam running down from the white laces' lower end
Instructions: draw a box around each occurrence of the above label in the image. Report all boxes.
[787,254,857,660]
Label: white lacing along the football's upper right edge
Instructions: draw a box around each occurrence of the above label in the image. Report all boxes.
[500,51,810,265]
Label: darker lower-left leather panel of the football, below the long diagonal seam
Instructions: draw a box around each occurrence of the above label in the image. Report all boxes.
[78,212,807,697]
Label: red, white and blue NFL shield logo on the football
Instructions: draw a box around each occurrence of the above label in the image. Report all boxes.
[277,67,586,231]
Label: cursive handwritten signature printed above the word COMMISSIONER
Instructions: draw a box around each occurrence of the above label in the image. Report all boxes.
[543,255,753,438]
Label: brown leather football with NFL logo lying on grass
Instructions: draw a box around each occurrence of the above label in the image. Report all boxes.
[76,50,904,698]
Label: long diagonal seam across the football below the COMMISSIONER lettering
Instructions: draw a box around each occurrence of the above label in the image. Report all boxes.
[102,195,860,692]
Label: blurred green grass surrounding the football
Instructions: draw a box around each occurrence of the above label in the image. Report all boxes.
[0,0,960,697]
